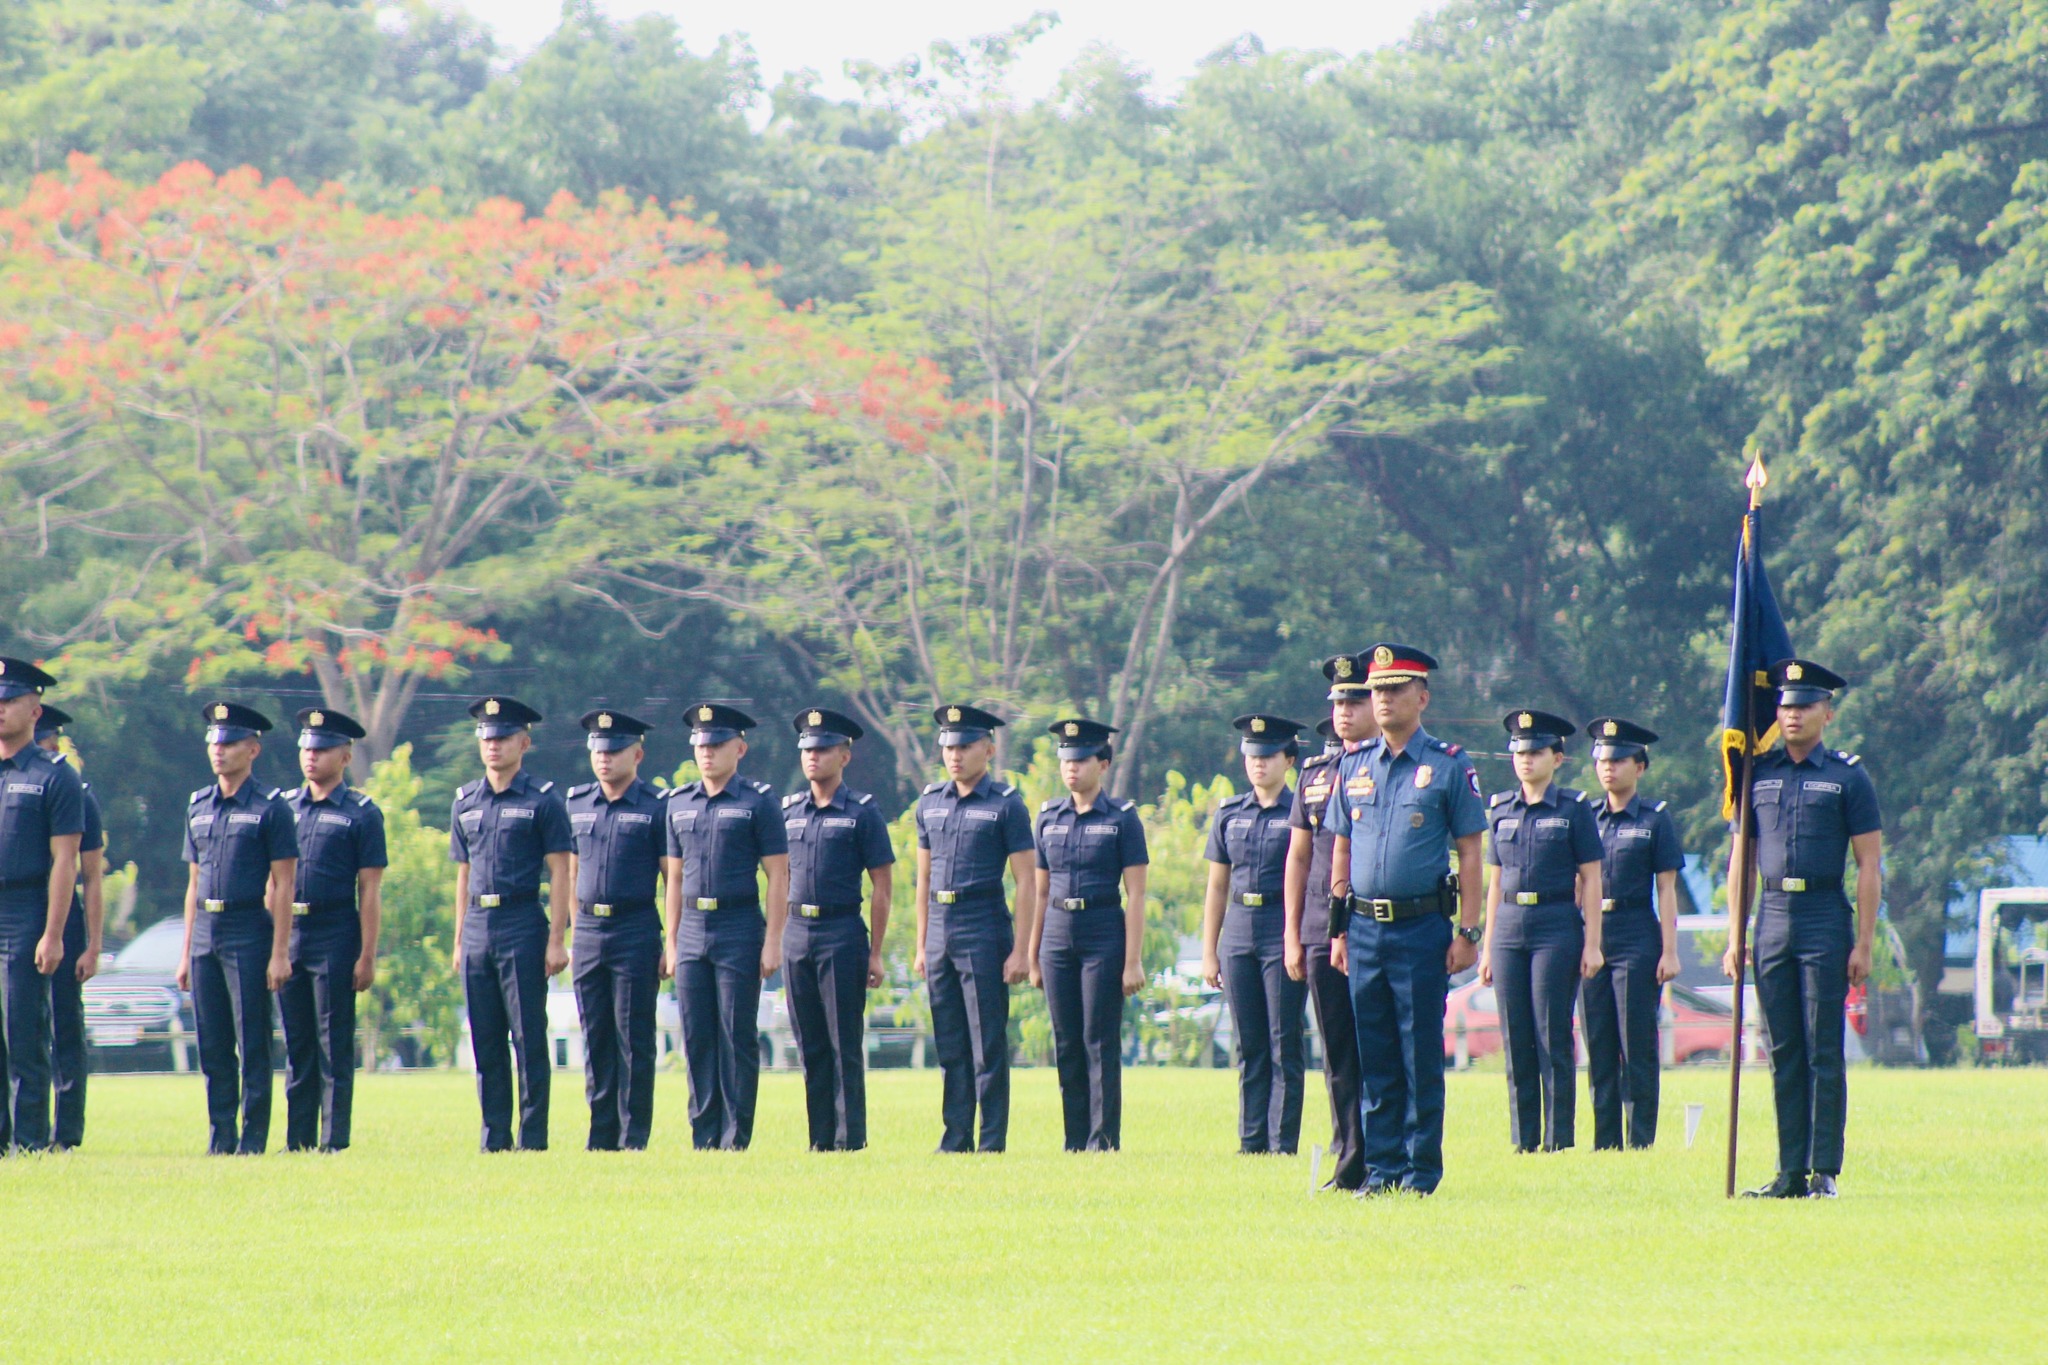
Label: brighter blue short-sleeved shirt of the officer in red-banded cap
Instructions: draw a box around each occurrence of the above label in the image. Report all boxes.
[1323,731,1487,900]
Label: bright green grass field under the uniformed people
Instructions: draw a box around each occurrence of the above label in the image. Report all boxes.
[0,1068,2048,1363]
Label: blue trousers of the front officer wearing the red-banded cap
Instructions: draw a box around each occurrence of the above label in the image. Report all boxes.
[1346,915,1450,1193]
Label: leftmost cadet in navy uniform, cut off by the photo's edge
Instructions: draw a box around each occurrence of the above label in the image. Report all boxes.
[0,659,86,1152]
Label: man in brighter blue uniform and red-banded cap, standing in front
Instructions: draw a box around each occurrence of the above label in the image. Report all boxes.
[1323,643,1487,1195]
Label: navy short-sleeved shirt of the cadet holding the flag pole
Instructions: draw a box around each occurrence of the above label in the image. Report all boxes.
[1749,747,1882,909]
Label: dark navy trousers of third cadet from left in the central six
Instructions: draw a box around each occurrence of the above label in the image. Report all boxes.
[676,907,768,1152]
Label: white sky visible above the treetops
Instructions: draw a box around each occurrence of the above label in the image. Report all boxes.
[455,0,1440,98]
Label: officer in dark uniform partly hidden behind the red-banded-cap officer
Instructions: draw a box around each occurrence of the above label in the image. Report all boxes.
[1286,655,1378,1189]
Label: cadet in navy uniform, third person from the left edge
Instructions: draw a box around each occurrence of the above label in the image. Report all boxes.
[178,702,299,1156]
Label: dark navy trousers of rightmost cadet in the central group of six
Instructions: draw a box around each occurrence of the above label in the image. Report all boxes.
[1048,907,1124,1152]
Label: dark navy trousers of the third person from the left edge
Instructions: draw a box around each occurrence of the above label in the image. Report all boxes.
[193,909,270,1156]
